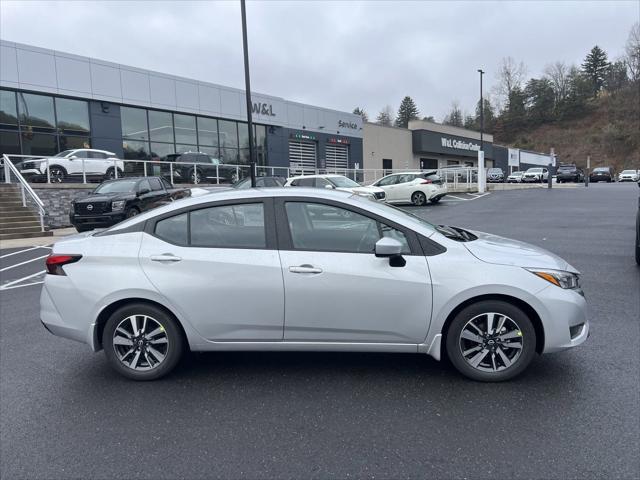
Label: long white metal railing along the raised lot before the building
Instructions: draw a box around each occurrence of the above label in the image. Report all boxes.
[4,155,478,188]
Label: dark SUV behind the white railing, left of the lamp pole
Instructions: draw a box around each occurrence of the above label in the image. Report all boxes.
[166,152,238,184]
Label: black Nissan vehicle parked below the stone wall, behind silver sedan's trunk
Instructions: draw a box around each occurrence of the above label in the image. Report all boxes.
[69,177,191,232]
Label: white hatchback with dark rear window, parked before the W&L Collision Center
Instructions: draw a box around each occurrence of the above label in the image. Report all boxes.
[371,170,447,206]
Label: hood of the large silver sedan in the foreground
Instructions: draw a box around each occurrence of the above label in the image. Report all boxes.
[463,232,579,273]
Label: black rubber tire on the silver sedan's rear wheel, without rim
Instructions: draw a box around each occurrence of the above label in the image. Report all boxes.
[102,303,185,381]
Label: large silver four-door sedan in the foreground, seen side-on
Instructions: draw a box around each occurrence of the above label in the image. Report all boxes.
[40,188,589,382]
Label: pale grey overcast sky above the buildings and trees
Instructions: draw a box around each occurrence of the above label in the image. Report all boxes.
[0,0,640,121]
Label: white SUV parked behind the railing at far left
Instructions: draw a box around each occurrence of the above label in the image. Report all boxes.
[16,148,124,183]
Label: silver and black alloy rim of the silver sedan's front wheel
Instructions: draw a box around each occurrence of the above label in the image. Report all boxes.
[459,312,524,372]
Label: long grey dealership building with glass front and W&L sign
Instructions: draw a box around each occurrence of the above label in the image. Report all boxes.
[0,40,363,172]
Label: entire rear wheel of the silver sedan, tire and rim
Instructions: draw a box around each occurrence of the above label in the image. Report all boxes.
[102,303,184,380]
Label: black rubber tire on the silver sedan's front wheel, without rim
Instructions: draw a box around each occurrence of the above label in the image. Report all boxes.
[445,300,536,382]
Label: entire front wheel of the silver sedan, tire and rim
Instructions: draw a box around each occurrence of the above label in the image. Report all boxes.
[446,300,536,382]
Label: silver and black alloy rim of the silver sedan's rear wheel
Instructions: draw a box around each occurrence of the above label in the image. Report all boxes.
[112,315,169,371]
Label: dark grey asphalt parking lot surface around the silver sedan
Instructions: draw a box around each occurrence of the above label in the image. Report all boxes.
[0,184,640,479]
